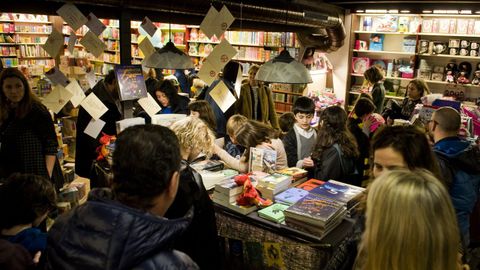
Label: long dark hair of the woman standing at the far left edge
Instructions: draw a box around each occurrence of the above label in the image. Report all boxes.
[0,68,39,123]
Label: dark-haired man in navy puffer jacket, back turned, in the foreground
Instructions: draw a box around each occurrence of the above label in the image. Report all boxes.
[47,125,198,270]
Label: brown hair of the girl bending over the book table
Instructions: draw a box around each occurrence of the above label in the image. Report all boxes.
[235,120,278,160]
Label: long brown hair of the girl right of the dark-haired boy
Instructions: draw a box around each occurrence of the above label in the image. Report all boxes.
[312,106,359,161]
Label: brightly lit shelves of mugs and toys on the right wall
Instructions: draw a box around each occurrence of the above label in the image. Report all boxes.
[346,13,480,108]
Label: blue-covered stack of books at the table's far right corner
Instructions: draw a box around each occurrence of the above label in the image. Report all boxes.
[310,180,365,216]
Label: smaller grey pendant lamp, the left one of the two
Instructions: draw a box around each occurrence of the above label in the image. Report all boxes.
[145,19,194,69]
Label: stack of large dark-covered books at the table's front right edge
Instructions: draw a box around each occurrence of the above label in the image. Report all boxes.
[284,193,346,236]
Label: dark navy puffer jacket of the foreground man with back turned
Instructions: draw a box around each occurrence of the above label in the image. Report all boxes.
[46,189,198,270]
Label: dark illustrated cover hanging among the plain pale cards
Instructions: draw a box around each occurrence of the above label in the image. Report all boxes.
[114,65,147,101]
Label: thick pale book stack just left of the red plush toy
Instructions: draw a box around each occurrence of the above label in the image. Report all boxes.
[212,177,257,215]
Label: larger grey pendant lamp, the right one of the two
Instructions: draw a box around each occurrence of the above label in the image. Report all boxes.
[255,10,312,84]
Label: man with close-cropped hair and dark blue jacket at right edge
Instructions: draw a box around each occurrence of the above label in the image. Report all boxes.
[428,107,480,246]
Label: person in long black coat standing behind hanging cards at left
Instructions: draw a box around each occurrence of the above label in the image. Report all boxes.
[75,70,122,181]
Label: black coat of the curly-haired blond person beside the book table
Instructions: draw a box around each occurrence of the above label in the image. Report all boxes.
[165,160,220,270]
